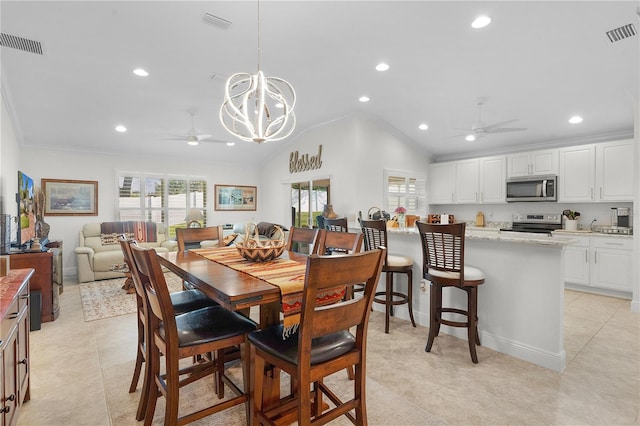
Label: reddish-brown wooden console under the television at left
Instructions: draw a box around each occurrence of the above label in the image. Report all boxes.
[9,250,60,322]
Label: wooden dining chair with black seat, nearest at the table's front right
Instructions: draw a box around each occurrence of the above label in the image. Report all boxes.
[248,249,385,425]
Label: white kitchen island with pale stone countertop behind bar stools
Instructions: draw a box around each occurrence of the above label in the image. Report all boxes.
[389,228,574,371]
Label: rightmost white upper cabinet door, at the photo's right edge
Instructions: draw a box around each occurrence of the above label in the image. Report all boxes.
[596,140,633,201]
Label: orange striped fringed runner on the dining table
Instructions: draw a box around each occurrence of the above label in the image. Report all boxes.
[190,247,345,337]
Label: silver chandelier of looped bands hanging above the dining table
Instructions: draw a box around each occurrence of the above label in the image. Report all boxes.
[220,1,296,143]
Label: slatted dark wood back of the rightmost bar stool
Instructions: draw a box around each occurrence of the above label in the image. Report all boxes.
[416,221,466,287]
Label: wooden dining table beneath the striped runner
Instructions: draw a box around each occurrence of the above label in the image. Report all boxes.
[157,250,308,412]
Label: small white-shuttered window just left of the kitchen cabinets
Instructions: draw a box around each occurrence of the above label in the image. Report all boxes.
[384,170,427,215]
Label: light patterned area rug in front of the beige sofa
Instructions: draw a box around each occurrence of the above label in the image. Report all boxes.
[78,272,182,322]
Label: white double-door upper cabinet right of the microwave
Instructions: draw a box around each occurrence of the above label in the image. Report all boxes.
[558,140,633,202]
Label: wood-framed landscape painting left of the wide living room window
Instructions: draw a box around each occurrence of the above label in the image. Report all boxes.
[42,179,98,216]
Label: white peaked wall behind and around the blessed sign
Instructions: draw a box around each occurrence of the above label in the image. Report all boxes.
[261,116,430,225]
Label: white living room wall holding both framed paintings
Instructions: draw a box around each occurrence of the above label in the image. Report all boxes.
[16,149,267,275]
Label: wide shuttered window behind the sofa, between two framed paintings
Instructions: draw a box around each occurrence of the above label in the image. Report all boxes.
[118,174,207,237]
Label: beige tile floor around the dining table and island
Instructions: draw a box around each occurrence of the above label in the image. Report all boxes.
[18,283,640,426]
